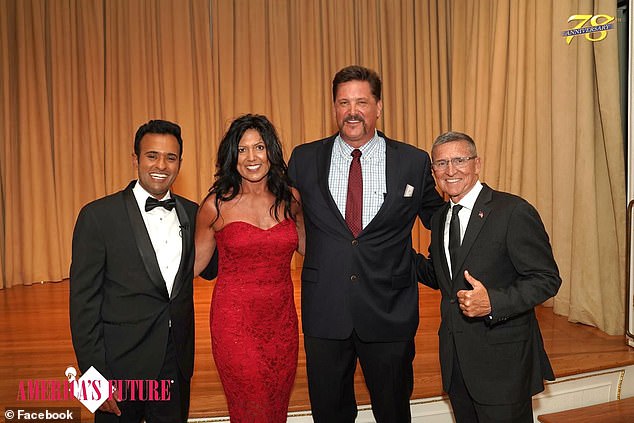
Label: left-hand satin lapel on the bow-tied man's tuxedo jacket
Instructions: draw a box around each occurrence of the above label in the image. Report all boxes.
[123,186,169,298]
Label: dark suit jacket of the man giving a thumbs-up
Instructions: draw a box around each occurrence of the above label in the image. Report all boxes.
[421,185,561,404]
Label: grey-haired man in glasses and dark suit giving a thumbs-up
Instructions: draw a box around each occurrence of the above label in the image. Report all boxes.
[420,132,561,423]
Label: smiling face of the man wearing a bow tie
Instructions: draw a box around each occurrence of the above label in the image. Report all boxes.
[132,134,181,199]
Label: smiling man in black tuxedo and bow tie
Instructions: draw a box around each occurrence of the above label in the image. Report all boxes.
[70,120,197,423]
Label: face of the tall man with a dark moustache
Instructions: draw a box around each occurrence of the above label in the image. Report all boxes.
[334,81,383,148]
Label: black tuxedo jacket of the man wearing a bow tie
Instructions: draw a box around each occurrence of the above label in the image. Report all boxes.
[70,182,198,379]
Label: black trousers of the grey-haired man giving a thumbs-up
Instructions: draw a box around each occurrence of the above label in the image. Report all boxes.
[448,351,533,423]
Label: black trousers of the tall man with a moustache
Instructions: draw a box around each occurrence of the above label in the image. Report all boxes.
[304,331,415,423]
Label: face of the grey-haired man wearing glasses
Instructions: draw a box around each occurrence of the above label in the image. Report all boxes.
[431,140,480,203]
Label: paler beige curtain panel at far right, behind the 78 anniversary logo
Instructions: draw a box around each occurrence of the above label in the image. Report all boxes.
[552,0,626,334]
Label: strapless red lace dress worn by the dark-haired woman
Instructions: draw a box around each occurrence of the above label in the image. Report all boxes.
[210,219,299,423]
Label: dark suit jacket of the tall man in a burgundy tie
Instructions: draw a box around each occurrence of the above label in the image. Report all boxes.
[289,132,443,342]
